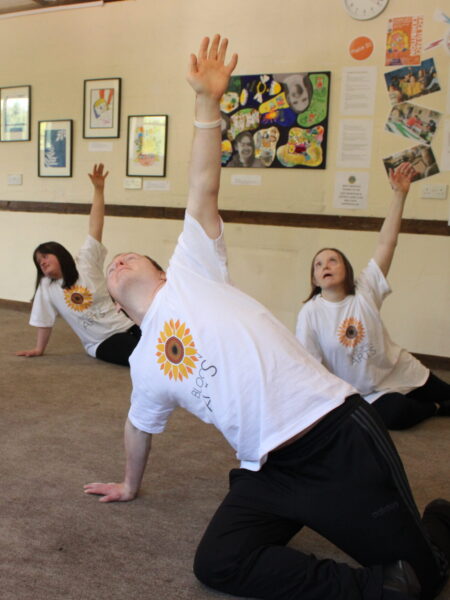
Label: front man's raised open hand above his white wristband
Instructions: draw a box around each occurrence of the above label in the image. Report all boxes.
[187,34,238,100]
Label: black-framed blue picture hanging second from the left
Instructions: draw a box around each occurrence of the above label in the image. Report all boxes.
[38,119,73,177]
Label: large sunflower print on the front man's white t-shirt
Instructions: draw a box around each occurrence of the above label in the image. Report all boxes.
[156,319,198,381]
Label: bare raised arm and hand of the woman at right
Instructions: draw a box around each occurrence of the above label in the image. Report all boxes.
[373,162,416,276]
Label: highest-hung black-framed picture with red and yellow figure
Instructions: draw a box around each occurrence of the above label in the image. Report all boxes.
[83,77,122,138]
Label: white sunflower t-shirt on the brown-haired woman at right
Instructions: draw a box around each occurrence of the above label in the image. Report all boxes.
[296,259,429,403]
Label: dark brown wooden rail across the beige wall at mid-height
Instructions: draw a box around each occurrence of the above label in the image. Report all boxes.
[0,200,450,236]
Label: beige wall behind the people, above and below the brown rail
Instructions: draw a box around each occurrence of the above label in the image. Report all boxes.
[0,0,450,356]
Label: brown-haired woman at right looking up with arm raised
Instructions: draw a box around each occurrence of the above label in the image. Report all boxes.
[296,163,450,429]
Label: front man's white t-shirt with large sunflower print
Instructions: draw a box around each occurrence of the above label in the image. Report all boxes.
[128,214,355,471]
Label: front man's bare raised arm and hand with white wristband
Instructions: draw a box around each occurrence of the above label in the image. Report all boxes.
[187,35,237,239]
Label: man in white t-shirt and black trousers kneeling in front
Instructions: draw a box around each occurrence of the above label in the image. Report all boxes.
[85,36,449,600]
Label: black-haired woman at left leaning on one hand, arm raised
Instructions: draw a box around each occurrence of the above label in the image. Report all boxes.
[16,164,141,366]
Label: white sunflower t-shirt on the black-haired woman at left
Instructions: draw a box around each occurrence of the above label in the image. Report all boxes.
[30,235,133,357]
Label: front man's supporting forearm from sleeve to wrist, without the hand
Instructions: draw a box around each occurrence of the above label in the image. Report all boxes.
[124,419,152,497]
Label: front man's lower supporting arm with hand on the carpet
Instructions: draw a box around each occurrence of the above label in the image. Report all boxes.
[84,419,152,502]
